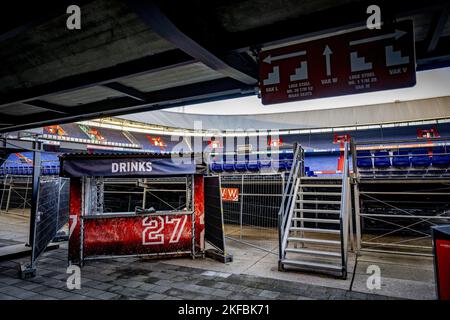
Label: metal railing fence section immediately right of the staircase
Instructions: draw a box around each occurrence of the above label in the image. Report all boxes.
[356,181,450,256]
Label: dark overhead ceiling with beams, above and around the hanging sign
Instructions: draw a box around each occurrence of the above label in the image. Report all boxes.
[0,0,450,132]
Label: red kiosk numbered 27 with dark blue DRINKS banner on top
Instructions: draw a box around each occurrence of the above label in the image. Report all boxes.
[60,153,205,265]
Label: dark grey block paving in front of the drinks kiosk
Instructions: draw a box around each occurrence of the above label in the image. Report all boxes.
[0,245,394,300]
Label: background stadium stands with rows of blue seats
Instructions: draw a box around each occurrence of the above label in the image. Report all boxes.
[2,122,450,174]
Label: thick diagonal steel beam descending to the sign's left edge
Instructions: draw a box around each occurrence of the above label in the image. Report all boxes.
[127,0,258,85]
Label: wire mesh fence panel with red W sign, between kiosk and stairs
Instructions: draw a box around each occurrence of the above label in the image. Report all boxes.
[221,174,284,254]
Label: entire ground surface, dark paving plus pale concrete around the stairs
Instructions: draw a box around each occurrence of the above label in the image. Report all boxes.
[0,215,434,300]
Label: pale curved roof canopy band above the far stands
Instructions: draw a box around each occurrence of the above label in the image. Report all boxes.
[120,96,450,131]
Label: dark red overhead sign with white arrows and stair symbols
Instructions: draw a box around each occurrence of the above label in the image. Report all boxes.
[259,20,416,104]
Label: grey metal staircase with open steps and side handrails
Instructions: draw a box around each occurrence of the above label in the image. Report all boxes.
[279,143,351,279]
